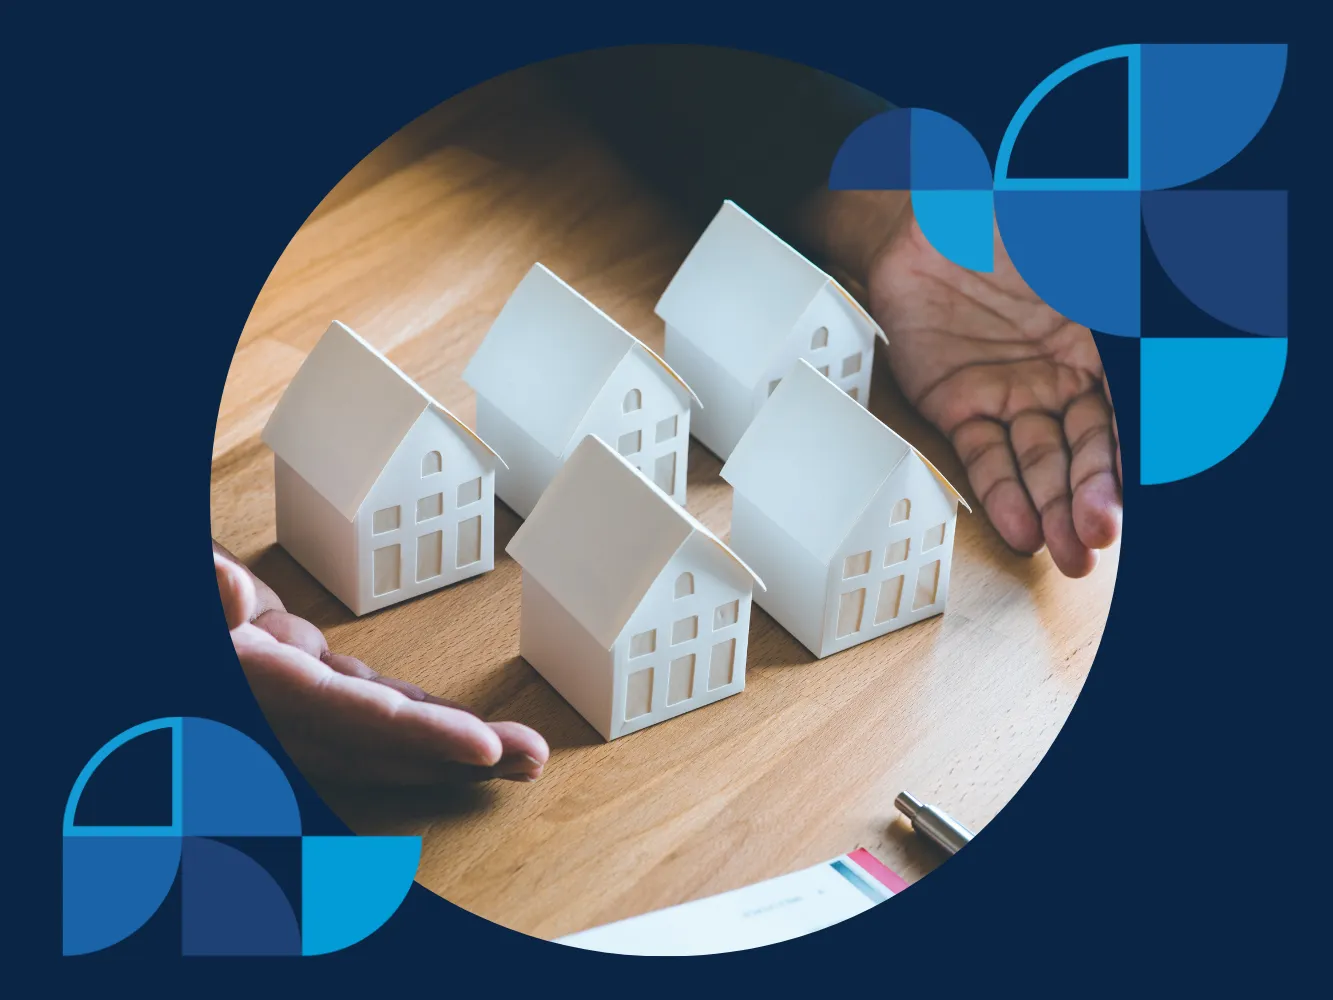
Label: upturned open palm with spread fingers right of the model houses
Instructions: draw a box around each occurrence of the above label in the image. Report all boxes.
[868,217,1121,576]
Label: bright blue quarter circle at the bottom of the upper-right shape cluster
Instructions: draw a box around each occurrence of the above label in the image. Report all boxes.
[1140,337,1286,485]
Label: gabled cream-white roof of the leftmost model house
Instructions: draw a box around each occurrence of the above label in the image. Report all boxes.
[263,320,504,520]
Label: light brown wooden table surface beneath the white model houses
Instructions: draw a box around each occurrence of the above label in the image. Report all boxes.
[212,66,1118,937]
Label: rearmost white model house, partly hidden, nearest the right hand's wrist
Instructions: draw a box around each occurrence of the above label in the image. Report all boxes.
[656,201,884,459]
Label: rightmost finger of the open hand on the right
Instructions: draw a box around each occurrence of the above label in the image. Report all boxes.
[1064,392,1122,548]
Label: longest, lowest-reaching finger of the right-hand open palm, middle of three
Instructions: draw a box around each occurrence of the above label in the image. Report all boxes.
[1009,411,1097,576]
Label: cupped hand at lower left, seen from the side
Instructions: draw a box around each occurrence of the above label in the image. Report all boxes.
[213,543,551,785]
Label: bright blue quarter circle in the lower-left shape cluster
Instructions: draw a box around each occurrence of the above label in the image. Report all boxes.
[301,837,421,955]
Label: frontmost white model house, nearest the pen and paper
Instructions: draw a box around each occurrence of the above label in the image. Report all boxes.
[508,436,762,740]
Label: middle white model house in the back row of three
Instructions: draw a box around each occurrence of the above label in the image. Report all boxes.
[463,264,693,517]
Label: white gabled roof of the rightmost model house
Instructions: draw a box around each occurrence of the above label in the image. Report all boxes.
[722,360,972,563]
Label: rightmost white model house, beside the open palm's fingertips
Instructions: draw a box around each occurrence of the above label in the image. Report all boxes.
[722,361,972,656]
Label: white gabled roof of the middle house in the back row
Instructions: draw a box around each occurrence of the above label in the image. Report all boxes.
[463,264,698,456]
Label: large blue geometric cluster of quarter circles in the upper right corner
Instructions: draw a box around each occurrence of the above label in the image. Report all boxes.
[829,44,1288,484]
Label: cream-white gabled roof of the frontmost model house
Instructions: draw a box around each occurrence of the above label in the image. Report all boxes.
[505,435,764,649]
